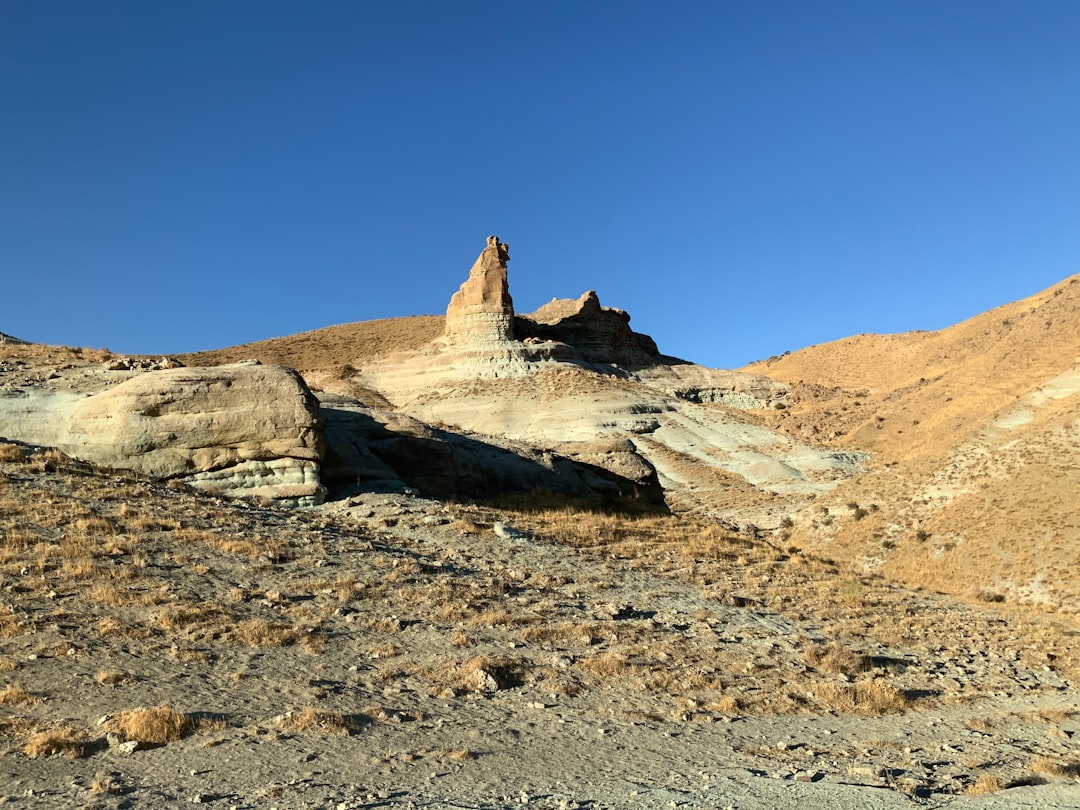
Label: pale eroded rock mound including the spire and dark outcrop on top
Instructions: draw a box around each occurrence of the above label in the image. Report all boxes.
[345,238,865,527]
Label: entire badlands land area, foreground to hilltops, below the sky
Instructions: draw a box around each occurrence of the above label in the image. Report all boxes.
[0,238,1080,808]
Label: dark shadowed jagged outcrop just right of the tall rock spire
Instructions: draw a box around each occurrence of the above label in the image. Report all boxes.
[517,291,660,364]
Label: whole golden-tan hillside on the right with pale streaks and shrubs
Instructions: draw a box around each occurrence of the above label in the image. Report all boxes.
[747,276,1080,610]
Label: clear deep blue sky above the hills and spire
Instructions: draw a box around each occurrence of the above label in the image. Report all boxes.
[0,0,1080,367]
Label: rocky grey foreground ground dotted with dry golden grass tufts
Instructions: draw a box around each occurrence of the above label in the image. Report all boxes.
[0,445,1080,808]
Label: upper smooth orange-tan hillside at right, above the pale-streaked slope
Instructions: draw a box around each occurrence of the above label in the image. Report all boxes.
[742,276,1080,461]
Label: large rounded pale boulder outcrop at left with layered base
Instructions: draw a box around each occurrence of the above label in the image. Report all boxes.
[0,364,325,505]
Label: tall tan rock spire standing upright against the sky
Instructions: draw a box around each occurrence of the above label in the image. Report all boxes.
[446,237,514,347]
